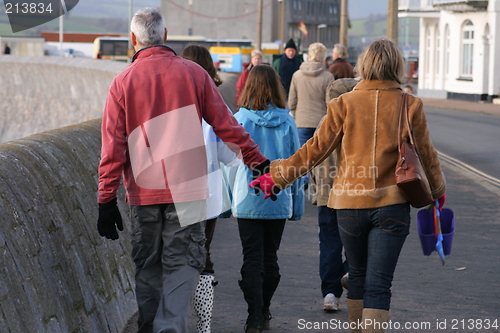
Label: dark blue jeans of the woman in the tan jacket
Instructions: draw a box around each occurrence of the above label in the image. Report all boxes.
[337,203,410,310]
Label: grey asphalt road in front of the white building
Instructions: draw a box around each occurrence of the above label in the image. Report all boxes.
[425,108,500,179]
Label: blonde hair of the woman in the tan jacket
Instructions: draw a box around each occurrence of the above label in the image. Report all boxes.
[356,38,405,84]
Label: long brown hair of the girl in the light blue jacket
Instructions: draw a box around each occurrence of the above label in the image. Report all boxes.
[237,65,286,110]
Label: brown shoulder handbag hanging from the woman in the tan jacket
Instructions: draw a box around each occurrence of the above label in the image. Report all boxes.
[396,93,434,208]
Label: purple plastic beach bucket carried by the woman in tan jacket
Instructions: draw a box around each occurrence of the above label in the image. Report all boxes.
[417,207,455,256]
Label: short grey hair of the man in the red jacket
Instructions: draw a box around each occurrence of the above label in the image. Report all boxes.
[130,8,166,46]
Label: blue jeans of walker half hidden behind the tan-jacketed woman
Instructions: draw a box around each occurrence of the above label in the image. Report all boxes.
[318,206,348,297]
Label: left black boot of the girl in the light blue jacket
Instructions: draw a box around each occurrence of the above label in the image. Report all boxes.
[238,275,263,333]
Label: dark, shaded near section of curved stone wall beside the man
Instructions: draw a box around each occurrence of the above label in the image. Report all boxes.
[0,119,136,333]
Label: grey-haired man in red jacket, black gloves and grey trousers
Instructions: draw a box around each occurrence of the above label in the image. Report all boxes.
[97,8,269,333]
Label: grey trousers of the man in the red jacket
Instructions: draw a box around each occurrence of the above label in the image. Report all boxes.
[131,204,206,333]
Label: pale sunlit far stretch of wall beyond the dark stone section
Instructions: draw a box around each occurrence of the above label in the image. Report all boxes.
[0,55,127,142]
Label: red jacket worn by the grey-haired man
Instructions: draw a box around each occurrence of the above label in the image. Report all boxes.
[98,46,266,205]
